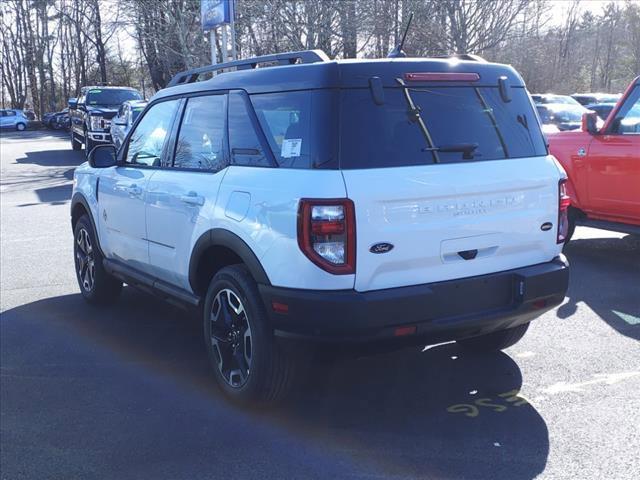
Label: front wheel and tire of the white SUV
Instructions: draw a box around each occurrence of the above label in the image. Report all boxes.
[73,214,122,305]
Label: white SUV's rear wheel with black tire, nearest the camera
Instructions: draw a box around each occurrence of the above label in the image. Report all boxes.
[203,265,299,404]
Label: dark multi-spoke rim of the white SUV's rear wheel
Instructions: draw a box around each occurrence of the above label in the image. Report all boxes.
[209,288,253,388]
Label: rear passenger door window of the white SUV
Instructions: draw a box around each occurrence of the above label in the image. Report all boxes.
[173,95,228,172]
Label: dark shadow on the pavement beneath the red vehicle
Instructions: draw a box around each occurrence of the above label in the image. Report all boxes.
[557,235,640,340]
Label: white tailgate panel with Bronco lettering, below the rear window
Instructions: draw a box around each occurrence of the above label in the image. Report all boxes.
[343,157,561,291]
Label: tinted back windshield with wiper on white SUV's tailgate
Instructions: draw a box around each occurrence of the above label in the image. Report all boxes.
[340,87,547,169]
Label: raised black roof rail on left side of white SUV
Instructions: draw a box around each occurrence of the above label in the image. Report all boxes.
[167,50,330,87]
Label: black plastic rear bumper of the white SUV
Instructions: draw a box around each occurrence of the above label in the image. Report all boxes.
[259,255,569,342]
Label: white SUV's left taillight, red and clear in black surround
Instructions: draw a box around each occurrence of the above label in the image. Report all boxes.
[298,198,356,275]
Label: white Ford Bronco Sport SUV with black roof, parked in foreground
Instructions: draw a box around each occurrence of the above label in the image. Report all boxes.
[71,51,568,401]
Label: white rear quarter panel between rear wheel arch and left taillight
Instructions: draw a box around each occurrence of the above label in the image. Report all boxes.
[212,166,355,290]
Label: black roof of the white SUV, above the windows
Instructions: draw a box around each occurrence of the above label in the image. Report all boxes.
[152,52,524,100]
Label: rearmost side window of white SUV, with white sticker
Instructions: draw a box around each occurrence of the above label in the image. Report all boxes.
[251,90,338,168]
